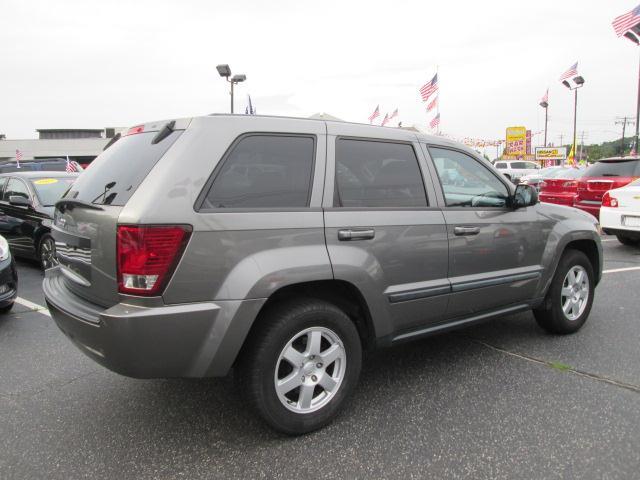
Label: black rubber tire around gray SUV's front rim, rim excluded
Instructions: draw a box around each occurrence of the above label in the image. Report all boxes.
[533,249,595,335]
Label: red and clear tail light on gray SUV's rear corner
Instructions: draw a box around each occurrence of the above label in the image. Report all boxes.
[117,225,191,296]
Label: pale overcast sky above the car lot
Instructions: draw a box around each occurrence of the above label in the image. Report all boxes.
[0,0,639,150]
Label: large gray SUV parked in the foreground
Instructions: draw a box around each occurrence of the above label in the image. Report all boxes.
[44,115,602,434]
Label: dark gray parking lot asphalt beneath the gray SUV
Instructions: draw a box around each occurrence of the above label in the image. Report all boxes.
[0,237,640,479]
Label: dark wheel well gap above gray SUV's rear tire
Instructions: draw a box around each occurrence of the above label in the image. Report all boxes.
[245,280,376,349]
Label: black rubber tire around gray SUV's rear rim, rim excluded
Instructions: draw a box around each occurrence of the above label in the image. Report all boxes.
[236,299,362,435]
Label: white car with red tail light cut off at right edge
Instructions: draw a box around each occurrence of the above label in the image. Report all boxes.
[600,178,640,245]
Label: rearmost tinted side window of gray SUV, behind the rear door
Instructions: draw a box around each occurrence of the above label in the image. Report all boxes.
[202,135,315,209]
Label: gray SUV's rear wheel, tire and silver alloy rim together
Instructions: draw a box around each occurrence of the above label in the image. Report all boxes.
[237,299,362,435]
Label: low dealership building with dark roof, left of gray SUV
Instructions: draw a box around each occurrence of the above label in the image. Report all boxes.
[0,128,123,165]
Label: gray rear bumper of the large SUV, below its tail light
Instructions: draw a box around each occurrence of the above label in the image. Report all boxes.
[43,268,264,378]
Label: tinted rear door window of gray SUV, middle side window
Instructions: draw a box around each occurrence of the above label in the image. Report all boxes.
[334,139,427,207]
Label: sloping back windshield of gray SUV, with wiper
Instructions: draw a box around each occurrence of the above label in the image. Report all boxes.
[65,130,183,206]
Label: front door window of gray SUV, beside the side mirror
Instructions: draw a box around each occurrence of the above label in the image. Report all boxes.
[429,147,509,207]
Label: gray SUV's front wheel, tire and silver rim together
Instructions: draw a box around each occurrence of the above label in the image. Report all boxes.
[533,250,595,334]
